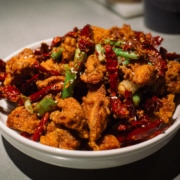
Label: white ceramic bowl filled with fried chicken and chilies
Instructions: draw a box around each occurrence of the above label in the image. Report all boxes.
[0,39,180,169]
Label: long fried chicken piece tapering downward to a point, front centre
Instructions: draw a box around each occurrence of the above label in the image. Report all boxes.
[82,85,110,150]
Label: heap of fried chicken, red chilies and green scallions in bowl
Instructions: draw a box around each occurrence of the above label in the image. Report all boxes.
[0,25,180,151]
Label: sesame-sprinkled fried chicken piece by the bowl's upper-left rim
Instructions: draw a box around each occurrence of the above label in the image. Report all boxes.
[4,48,37,85]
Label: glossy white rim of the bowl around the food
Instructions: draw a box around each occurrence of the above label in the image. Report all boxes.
[0,38,180,158]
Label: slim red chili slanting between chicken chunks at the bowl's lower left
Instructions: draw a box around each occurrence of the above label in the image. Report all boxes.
[31,112,49,141]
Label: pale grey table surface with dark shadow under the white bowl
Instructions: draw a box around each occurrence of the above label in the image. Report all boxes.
[0,0,180,180]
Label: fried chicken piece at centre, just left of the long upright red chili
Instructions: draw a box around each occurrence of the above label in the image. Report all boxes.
[80,55,106,84]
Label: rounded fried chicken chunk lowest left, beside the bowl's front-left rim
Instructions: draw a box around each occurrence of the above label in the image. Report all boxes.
[7,106,40,134]
